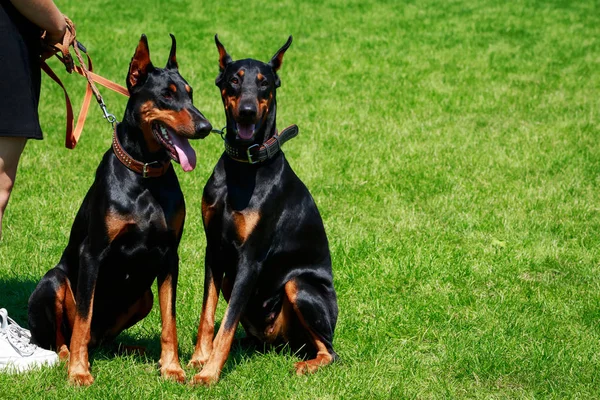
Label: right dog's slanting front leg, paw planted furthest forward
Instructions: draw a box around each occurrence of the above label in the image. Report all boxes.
[193,265,259,386]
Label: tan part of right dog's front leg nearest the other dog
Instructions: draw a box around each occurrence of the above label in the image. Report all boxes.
[189,277,219,368]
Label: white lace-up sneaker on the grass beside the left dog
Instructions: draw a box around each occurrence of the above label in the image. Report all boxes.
[0,308,58,372]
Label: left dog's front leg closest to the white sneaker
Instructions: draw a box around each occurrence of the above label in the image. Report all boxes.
[68,240,106,386]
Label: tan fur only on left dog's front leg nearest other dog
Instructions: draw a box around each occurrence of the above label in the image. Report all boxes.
[158,275,185,383]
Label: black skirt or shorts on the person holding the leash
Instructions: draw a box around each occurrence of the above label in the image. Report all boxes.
[0,0,42,139]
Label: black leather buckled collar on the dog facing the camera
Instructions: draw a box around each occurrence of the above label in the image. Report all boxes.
[224,125,298,164]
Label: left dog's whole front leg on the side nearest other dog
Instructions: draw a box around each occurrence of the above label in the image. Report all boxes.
[158,253,185,383]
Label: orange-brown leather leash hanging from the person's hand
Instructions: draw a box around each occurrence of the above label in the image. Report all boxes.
[41,16,129,149]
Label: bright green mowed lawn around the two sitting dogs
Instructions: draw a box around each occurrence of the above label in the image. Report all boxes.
[0,0,600,399]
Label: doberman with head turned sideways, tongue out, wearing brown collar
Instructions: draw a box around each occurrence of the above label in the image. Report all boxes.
[29,35,212,386]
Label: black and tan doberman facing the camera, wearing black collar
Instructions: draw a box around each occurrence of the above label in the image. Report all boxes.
[190,36,338,385]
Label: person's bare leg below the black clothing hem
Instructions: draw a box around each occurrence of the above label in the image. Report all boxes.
[0,137,27,239]
